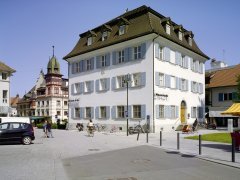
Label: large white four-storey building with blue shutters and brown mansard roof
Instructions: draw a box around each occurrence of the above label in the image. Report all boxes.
[64,6,209,132]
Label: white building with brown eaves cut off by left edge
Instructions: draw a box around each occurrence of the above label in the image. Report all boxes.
[0,61,16,116]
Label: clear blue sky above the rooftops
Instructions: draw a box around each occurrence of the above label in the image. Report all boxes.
[0,0,240,96]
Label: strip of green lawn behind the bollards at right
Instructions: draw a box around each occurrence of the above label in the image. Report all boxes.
[184,133,232,144]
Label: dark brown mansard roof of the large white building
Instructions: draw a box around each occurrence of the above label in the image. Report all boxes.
[63,6,209,60]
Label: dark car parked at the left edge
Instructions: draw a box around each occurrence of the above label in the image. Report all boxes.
[0,122,35,145]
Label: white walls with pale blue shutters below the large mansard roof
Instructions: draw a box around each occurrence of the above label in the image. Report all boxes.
[68,34,206,132]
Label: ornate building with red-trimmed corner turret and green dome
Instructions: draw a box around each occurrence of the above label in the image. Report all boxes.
[18,55,68,122]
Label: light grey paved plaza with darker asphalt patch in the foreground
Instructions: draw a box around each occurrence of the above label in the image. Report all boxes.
[0,129,240,180]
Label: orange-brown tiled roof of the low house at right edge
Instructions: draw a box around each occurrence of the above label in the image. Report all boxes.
[206,64,240,88]
